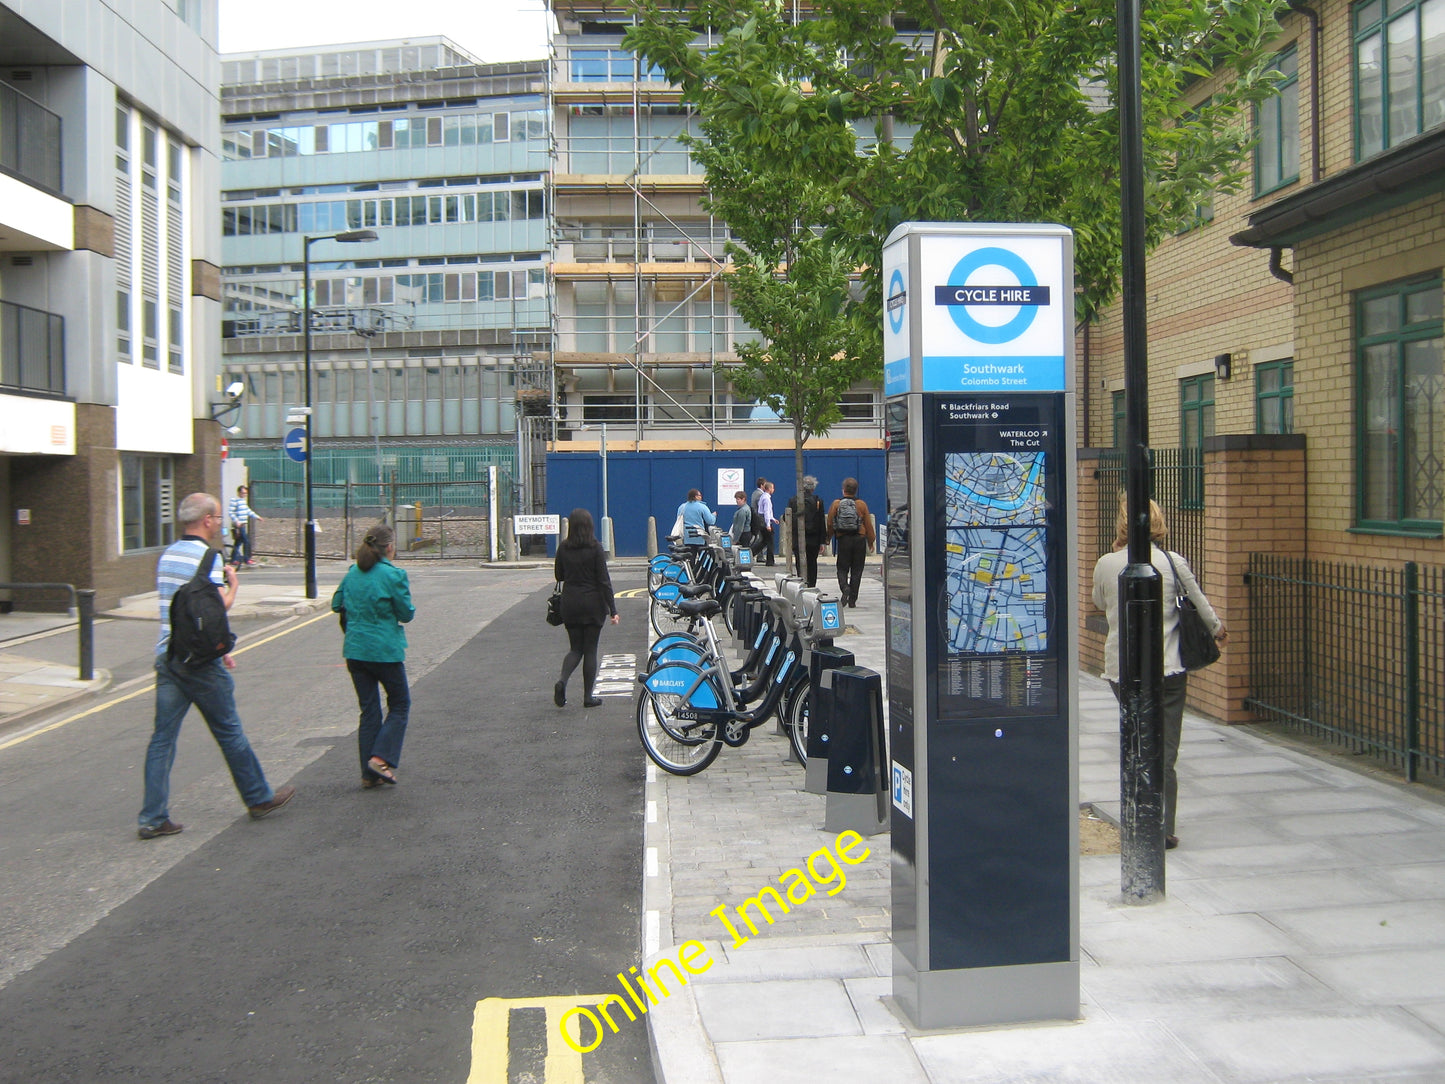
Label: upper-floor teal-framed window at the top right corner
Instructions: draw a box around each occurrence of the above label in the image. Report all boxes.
[1351,0,1445,160]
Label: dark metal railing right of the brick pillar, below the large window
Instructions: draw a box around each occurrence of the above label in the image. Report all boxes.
[1246,554,1445,782]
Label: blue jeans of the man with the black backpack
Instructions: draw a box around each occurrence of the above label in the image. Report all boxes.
[140,655,276,828]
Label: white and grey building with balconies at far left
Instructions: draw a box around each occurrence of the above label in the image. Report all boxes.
[0,0,221,606]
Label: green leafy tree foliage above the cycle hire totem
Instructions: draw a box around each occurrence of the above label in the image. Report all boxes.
[626,0,1286,352]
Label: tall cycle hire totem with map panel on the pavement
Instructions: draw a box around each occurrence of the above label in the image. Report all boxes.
[883,223,1079,1028]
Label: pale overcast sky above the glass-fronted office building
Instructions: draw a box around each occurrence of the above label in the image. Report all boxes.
[221,0,551,64]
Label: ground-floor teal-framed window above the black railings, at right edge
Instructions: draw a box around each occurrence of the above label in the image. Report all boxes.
[1355,275,1445,535]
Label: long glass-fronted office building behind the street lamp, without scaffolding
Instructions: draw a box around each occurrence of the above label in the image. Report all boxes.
[220,38,551,511]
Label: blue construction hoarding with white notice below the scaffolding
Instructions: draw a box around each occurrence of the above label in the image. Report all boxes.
[546,448,887,556]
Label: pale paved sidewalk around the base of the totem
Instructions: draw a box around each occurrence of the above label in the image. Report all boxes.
[643,569,1445,1084]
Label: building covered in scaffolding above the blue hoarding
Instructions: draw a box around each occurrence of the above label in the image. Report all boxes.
[548,0,881,462]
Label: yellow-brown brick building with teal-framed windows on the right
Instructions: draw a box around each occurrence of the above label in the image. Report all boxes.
[1078,0,1445,752]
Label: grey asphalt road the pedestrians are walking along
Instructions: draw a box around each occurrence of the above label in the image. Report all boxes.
[0,565,652,1084]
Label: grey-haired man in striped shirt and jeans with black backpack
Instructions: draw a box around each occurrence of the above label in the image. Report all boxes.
[139,493,296,840]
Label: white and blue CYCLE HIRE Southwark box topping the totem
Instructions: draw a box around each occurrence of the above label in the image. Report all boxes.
[883,223,1074,395]
